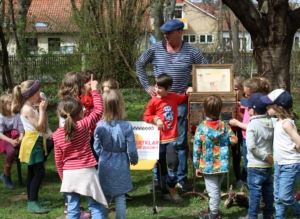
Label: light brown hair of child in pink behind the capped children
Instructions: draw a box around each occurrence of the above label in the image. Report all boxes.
[243,77,271,95]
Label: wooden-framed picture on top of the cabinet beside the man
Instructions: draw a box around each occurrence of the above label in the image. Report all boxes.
[192,64,234,94]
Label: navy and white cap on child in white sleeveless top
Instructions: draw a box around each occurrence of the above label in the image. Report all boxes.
[260,89,293,109]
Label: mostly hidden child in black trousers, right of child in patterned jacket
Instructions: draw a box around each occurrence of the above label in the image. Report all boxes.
[231,76,247,189]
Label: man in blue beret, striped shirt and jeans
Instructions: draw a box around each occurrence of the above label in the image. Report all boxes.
[136,19,207,191]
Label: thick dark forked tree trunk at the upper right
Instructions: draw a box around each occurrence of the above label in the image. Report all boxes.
[222,0,300,91]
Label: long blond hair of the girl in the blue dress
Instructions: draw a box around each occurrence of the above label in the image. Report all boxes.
[102,89,126,122]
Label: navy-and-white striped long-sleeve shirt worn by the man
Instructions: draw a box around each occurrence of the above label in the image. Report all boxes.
[136,40,207,94]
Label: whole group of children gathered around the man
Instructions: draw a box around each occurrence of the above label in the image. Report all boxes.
[0,71,300,219]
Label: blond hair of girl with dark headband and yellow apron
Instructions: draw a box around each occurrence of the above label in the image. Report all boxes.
[11,80,35,115]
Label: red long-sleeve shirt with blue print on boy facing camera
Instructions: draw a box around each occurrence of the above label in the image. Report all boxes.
[143,93,188,144]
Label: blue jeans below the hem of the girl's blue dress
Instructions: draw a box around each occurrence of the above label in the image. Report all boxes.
[99,194,126,219]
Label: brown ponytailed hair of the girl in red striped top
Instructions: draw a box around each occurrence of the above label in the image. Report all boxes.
[57,97,83,142]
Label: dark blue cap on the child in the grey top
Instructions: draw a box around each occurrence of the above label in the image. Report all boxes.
[241,93,268,114]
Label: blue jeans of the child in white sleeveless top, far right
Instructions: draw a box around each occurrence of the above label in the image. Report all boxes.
[274,162,300,219]
